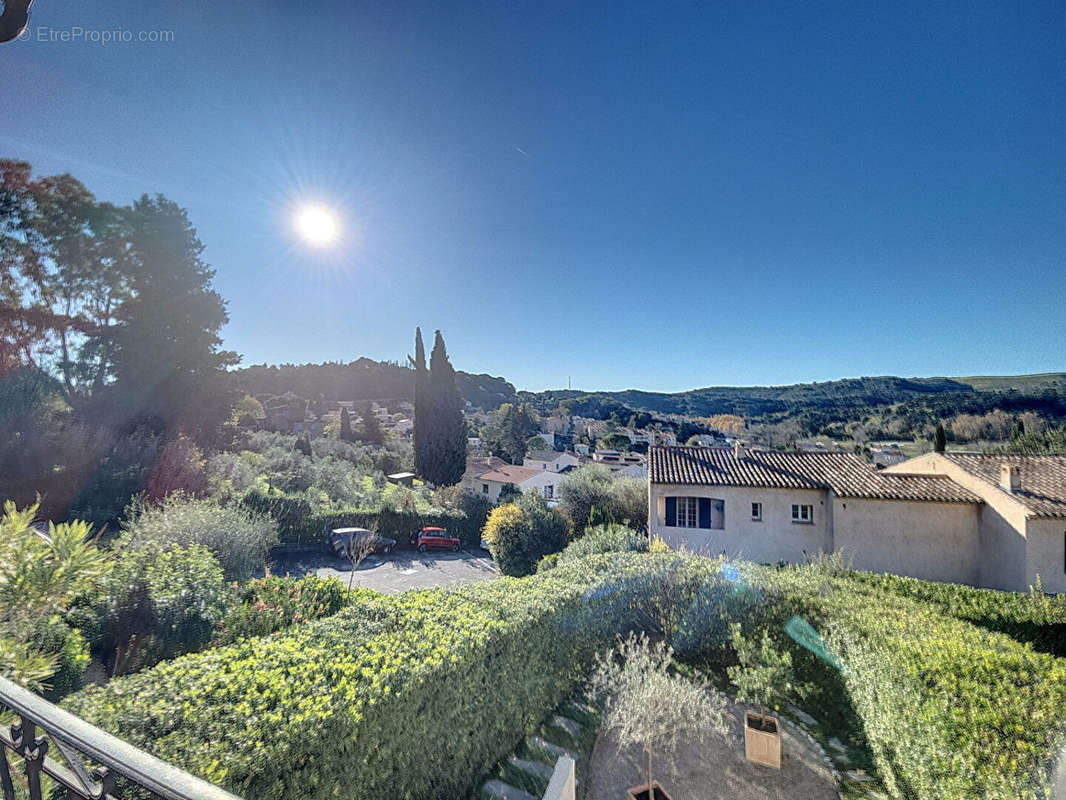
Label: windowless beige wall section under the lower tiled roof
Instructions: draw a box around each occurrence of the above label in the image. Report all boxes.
[833,497,981,585]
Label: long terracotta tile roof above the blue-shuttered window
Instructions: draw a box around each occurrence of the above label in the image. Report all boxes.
[648,447,981,502]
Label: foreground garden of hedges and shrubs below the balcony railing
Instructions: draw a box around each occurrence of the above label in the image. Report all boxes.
[6,496,1066,800]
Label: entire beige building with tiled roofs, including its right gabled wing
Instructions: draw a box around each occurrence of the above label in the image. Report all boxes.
[648,445,1066,592]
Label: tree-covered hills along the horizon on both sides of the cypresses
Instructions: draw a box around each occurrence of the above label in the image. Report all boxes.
[233,358,1066,429]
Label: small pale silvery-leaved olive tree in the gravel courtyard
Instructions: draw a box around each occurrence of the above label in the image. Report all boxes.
[588,634,727,800]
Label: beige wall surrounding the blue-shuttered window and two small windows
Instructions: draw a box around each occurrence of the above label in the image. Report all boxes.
[648,483,831,563]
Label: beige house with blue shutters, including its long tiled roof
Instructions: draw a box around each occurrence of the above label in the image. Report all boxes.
[648,443,989,588]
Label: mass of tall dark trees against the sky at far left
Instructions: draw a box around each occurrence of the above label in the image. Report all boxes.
[0,160,236,525]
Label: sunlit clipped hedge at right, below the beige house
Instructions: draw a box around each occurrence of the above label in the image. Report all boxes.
[758,567,1066,800]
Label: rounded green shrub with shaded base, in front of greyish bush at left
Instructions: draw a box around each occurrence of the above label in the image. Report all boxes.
[82,541,229,675]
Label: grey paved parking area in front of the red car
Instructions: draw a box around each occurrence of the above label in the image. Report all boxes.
[271,549,500,594]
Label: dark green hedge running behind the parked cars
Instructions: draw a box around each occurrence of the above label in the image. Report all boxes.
[241,490,482,547]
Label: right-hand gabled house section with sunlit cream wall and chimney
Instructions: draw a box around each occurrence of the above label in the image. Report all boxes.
[885,452,1066,593]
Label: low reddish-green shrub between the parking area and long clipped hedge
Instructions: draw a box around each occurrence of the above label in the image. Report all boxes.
[214,575,353,644]
